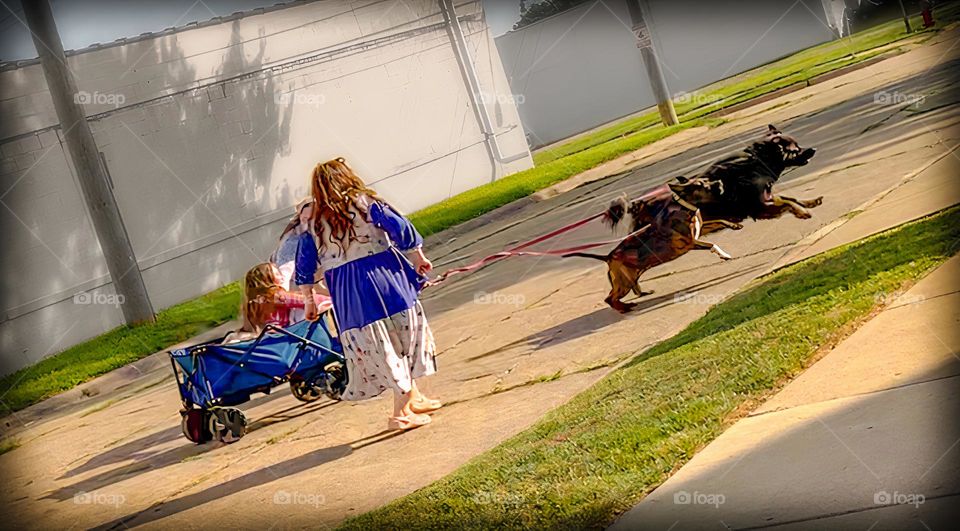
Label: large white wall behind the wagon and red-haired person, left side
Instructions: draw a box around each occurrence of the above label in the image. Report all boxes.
[0,0,532,374]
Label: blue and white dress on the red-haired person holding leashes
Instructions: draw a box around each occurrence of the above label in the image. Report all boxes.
[295,196,437,400]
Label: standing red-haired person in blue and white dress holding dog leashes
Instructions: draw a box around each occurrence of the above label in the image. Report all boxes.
[295,158,441,430]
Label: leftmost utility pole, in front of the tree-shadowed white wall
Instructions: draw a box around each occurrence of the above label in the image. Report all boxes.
[23,0,155,324]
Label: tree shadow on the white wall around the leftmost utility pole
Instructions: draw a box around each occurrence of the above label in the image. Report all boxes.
[0,16,300,373]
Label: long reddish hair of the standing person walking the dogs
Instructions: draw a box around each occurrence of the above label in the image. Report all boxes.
[310,157,381,254]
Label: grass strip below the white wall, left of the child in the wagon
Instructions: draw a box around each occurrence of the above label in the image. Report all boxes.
[0,282,240,415]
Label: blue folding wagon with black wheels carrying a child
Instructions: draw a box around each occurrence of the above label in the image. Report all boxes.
[170,316,347,444]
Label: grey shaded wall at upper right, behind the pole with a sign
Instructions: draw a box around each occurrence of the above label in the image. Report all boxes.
[496,0,833,146]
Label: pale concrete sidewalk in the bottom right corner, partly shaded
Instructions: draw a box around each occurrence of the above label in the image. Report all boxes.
[611,256,960,531]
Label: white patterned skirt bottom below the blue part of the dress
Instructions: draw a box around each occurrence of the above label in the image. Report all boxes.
[340,301,437,400]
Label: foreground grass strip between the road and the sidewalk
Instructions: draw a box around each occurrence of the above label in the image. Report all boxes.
[342,207,960,529]
